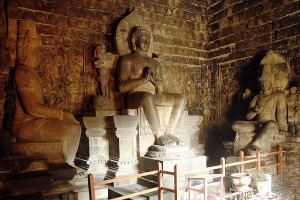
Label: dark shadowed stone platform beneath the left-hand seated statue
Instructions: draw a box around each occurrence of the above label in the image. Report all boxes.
[0,157,76,199]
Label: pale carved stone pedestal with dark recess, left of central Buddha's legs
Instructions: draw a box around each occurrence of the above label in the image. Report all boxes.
[81,115,138,185]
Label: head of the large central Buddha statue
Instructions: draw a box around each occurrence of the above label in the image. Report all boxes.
[131,26,151,52]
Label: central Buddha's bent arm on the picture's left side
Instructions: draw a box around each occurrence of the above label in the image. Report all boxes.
[118,59,151,93]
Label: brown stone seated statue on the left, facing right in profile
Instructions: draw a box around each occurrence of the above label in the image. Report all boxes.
[12,19,81,165]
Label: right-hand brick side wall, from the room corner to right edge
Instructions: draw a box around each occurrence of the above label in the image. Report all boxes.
[208,0,300,133]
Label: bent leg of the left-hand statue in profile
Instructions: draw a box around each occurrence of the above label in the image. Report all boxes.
[13,119,81,164]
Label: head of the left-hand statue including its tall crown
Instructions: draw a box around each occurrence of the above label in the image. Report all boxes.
[17,19,42,68]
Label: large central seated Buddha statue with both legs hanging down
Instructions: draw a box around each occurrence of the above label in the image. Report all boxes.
[118,26,187,146]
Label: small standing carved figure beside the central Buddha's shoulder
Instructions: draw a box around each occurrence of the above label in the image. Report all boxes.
[94,44,113,99]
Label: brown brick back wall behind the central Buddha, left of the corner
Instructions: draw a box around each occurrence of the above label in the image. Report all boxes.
[0,0,210,142]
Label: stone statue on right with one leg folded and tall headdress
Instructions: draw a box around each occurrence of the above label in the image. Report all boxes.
[232,51,288,155]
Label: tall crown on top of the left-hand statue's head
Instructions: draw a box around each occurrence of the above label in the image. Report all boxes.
[18,19,39,38]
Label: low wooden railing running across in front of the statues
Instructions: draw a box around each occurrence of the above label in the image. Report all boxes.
[88,145,283,200]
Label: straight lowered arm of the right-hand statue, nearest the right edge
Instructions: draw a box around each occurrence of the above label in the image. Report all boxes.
[276,94,288,131]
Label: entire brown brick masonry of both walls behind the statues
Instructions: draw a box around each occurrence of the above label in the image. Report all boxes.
[0,0,300,148]
